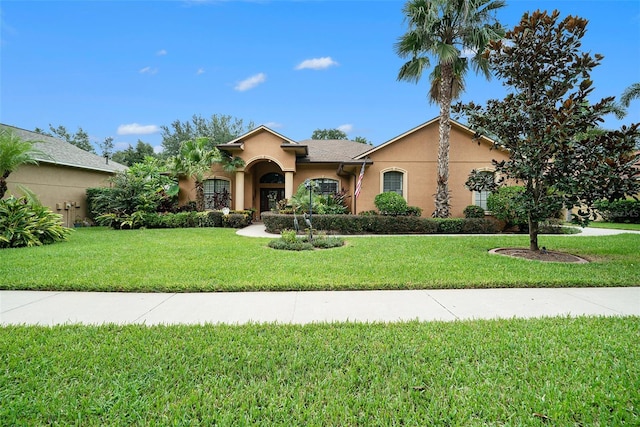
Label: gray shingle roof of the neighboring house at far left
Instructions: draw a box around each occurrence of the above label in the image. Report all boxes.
[0,124,127,173]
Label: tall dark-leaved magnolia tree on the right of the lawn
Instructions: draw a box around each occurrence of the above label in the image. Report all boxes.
[455,11,640,251]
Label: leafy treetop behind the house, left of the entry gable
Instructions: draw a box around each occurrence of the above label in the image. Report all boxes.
[160,114,255,157]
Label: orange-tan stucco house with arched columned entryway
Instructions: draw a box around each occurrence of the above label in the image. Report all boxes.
[180,118,508,217]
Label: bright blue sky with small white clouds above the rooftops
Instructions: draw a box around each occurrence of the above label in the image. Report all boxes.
[0,0,640,154]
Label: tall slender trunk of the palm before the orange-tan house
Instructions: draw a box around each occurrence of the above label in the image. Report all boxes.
[432,63,453,218]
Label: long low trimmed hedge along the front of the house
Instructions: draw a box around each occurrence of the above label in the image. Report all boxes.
[262,212,497,234]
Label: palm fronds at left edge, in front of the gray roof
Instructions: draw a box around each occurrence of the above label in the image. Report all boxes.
[0,128,44,199]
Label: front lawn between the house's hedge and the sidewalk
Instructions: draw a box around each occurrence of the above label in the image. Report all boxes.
[0,228,640,292]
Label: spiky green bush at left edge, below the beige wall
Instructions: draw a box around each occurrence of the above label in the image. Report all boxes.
[0,196,71,248]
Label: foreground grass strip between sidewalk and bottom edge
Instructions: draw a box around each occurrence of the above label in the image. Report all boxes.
[0,317,640,426]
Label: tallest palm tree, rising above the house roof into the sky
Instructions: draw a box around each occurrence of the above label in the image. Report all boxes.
[395,0,505,218]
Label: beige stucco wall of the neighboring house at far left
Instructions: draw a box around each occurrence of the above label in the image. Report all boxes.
[7,163,112,227]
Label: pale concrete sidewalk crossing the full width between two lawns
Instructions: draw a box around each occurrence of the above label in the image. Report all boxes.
[0,287,640,325]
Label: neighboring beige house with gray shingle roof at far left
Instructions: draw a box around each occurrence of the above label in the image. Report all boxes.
[0,124,127,227]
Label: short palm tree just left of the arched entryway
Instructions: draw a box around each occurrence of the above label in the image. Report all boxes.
[167,138,221,212]
